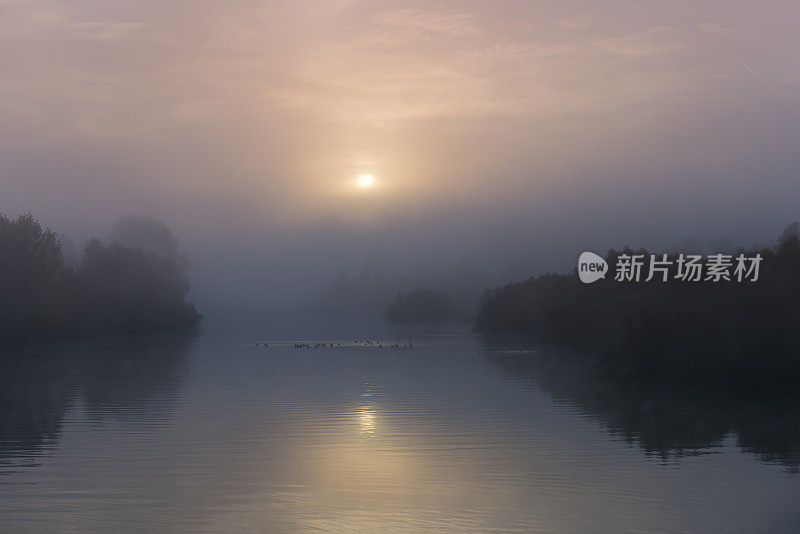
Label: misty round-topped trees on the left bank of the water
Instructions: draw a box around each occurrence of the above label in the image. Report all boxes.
[0,213,201,346]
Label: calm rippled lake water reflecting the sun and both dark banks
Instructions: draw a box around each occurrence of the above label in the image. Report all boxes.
[0,325,800,533]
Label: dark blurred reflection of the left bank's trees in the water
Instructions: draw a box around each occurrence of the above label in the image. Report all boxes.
[0,333,193,474]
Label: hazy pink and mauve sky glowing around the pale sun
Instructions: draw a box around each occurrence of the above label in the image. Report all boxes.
[0,0,800,314]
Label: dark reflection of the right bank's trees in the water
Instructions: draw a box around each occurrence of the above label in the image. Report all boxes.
[485,340,800,474]
